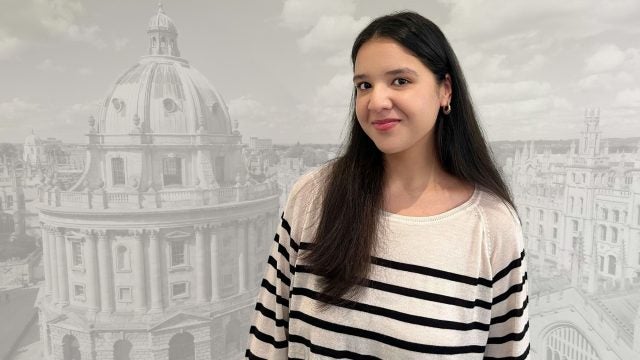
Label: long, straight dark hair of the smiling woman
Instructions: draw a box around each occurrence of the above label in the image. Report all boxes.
[301,12,515,307]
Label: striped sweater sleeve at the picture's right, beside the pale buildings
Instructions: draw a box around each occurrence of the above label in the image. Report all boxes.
[484,204,530,359]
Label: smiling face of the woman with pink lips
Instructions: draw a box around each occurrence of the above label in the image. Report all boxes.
[353,38,451,155]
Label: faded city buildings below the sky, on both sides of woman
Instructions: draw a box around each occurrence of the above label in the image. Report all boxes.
[0,0,640,360]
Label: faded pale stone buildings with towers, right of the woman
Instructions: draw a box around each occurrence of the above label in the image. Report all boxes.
[503,109,640,360]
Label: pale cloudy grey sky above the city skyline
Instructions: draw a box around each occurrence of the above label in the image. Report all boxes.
[0,0,640,144]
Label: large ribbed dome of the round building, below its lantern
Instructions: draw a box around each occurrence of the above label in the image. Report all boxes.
[98,56,232,135]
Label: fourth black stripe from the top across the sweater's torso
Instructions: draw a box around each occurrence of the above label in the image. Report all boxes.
[289,310,485,354]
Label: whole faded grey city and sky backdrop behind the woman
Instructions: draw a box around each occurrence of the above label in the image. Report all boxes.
[0,0,640,360]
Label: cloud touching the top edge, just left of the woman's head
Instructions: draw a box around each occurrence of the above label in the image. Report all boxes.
[280,0,356,30]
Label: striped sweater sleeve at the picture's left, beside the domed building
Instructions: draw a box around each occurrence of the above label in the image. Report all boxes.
[245,168,312,360]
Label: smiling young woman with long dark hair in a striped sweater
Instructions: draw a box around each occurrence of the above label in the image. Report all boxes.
[246,12,529,359]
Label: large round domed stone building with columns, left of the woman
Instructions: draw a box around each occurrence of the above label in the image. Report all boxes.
[38,6,280,360]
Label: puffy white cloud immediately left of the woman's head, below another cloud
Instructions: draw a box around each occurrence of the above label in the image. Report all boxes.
[298,15,371,53]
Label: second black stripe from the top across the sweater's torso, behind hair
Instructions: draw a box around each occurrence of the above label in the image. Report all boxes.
[296,264,491,310]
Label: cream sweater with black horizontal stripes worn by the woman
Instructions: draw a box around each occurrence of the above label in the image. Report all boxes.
[245,167,529,359]
